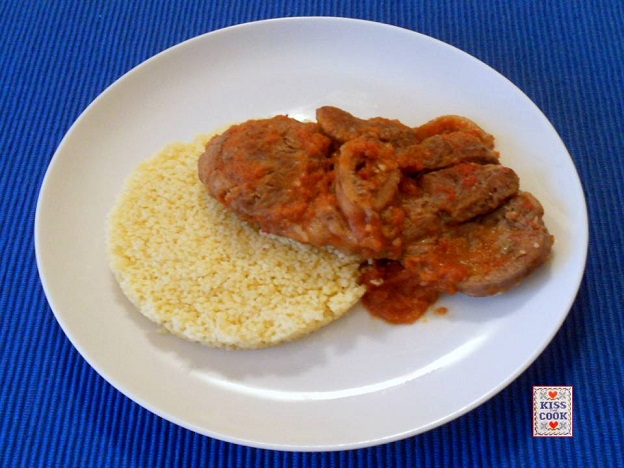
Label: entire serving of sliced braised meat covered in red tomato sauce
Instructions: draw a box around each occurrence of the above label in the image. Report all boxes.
[198,106,553,324]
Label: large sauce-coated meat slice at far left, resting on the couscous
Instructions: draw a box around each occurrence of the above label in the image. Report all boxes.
[199,116,347,244]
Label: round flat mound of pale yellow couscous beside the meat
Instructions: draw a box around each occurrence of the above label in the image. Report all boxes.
[107,136,365,349]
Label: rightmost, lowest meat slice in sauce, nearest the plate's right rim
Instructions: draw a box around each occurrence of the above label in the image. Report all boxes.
[403,192,554,296]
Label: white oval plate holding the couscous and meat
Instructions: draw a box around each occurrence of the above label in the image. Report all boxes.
[35,18,587,450]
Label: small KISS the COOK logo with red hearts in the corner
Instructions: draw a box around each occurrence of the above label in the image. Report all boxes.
[533,387,573,437]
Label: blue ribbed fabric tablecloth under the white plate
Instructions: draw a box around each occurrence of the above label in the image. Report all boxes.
[0,0,624,467]
